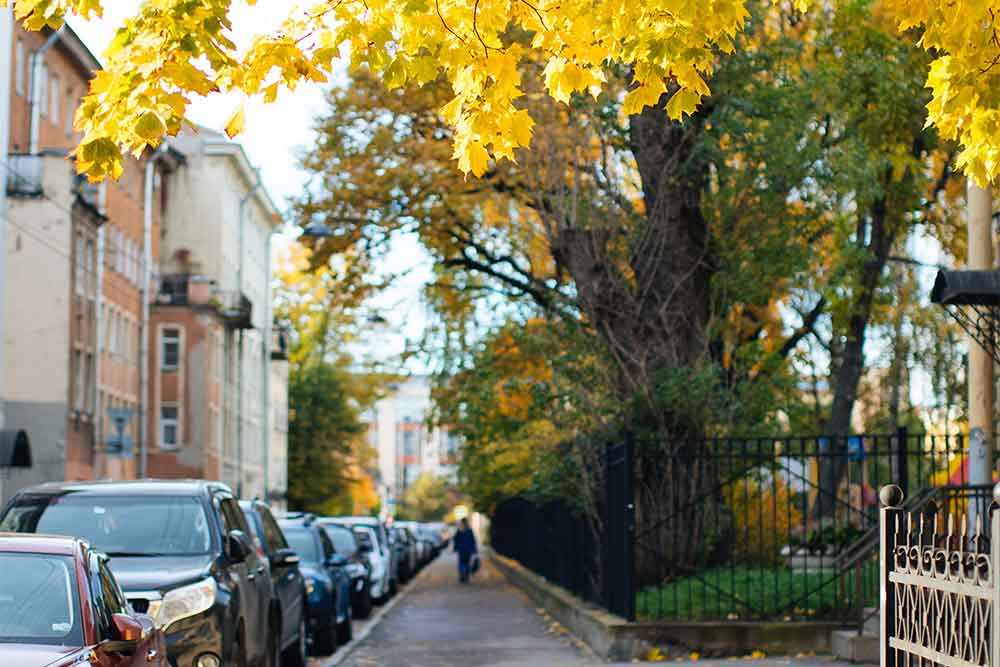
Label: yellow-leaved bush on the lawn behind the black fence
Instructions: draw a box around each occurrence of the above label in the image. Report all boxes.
[725,472,801,564]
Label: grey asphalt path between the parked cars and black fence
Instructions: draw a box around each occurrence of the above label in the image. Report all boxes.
[332,553,600,667]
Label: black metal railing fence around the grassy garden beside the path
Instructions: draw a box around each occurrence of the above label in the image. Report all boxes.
[493,430,976,621]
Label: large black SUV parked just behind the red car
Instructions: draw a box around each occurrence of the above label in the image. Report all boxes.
[0,480,278,667]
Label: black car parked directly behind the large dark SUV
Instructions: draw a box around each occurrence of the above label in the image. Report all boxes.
[240,500,308,667]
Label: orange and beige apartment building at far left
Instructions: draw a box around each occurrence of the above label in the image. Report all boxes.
[2,25,173,496]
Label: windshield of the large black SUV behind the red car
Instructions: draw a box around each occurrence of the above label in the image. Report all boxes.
[0,494,212,556]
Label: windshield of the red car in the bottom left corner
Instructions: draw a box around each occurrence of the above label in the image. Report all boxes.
[0,553,83,646]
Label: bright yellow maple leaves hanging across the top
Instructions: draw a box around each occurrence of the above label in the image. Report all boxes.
[0,0,1000,182]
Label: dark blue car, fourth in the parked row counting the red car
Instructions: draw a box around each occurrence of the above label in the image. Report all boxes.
[279,514,353,655]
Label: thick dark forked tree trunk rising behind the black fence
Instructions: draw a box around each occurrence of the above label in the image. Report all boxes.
[552,105,715,583]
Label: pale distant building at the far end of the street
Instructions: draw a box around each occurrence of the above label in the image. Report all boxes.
[365,375,459,500]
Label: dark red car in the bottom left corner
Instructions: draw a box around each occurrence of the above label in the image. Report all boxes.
[0,533,168,667]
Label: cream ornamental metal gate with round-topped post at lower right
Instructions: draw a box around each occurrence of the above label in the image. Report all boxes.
[880,486,1000,667]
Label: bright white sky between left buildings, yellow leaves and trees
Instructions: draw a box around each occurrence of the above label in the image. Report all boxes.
[69,0,431,372]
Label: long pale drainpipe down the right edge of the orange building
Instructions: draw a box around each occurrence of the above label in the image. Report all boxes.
[139,143,167,479]
